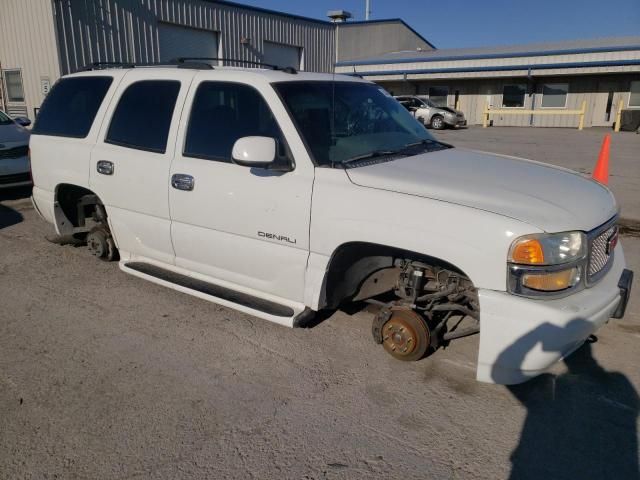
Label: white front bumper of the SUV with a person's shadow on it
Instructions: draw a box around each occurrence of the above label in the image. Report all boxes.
[477,245,633,385]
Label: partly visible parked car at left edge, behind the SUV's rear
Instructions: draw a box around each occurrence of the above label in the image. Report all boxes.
[0,110,31,188]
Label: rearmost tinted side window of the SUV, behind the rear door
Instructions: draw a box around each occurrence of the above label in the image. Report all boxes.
[31,77,113,138]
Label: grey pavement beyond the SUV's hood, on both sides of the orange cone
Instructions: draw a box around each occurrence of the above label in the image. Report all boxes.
[430,126,640,223]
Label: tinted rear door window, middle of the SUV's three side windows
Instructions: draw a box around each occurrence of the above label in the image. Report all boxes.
[105,80,180,153]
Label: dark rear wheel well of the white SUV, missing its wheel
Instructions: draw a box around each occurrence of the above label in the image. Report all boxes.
[56,183,102,230]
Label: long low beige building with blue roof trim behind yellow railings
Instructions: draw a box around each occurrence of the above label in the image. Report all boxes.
[336,37,640,127]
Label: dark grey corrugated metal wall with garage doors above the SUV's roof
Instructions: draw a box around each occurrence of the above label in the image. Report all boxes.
[53,0,335,73]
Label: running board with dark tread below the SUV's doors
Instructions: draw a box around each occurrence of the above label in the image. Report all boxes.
[123,262,296,324]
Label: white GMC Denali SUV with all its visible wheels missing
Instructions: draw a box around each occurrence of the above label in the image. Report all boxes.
[31,61,632,384]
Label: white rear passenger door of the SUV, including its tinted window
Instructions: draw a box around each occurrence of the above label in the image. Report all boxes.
[89,69,194,263]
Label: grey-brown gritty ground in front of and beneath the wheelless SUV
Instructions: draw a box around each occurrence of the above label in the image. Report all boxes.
[0,182,640,480]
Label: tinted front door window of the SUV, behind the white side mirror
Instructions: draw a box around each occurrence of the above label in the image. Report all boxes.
[184,82,288,163]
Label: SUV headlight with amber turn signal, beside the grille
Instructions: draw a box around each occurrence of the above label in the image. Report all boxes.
[508,232,587,297]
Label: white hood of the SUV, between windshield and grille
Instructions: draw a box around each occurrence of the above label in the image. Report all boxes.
[346,148,617,232]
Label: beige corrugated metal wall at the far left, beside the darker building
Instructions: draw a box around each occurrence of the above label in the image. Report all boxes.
[0,0,60,119]
